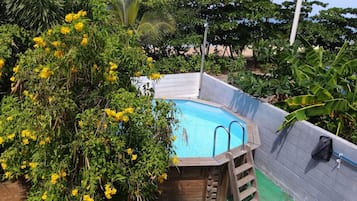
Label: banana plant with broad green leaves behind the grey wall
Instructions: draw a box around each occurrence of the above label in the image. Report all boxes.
[278,43,357,139]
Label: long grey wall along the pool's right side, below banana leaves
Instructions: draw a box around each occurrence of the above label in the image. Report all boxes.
[200,74,357,201]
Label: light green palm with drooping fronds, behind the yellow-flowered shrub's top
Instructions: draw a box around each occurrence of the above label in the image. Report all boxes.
[109,0,175,44]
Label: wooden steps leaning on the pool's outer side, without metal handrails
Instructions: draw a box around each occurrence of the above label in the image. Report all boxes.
[226,145,259,201]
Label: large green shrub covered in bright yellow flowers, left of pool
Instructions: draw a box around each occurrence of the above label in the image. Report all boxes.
[0,8,177,201]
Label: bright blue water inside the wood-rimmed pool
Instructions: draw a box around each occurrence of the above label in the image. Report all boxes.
[172,100,247,158]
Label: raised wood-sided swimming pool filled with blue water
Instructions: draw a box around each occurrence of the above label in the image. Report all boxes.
[159,99,260,201]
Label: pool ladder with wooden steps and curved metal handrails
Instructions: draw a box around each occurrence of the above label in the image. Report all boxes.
[213,121,259,201]
